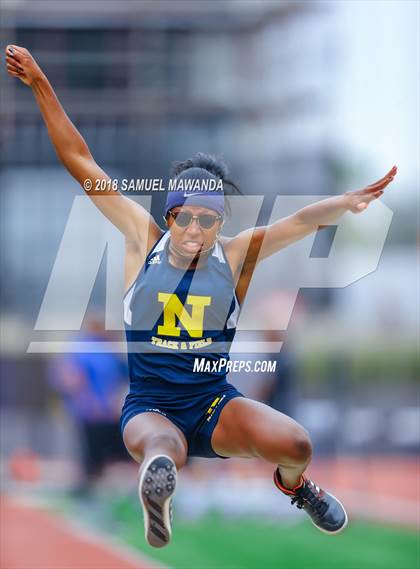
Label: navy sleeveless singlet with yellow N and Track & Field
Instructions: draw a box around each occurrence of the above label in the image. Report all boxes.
[124,231,240,393]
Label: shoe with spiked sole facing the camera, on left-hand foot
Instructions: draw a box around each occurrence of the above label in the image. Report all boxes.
[139,454,177,547]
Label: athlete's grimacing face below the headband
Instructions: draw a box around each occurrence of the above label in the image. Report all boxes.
[168,205,223,257]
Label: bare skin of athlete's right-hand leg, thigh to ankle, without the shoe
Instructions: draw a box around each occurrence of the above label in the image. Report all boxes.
[211,397,312,488]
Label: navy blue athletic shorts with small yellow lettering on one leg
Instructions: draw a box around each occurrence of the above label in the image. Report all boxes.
[120,379,244,458]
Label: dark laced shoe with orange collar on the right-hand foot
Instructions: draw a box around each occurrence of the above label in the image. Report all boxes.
[274,469,348,534]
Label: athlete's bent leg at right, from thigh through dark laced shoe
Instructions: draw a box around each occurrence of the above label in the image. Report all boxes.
[211,397,348,534]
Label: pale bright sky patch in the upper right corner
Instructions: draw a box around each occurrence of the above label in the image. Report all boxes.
[334,0,420,199]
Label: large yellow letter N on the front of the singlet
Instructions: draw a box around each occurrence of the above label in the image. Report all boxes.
[157,292,211,338]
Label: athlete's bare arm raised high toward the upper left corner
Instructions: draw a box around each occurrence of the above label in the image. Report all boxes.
[5,45,160,243]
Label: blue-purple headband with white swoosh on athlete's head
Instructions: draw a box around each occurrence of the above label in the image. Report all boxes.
[165,168,225,216]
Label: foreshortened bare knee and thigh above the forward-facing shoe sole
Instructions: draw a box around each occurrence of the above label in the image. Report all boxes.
[123,413,188,470]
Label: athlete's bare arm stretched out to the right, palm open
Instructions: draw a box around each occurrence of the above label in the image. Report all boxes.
[229,166,397,266]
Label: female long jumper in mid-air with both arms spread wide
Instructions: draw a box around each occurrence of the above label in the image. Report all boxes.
[6,45,397,547]
